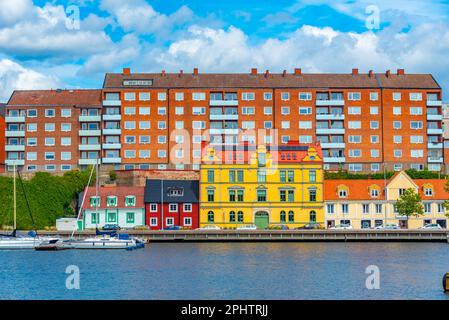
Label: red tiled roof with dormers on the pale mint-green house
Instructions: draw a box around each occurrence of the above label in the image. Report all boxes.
[83,186,145,209]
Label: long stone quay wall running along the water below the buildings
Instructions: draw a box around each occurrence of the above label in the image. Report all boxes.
[38,230,448,243]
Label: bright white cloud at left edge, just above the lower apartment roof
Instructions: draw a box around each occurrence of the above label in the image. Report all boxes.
[0,59,60,101]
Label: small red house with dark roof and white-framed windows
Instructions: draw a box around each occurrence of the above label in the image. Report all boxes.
[145,180,199,230]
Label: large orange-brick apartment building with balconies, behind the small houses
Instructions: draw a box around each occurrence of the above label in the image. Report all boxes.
[5,68,444,172]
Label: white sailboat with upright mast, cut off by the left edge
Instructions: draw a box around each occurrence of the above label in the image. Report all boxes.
[0,163,58,250]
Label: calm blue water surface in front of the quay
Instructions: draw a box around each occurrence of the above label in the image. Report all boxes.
[0,243,449,300]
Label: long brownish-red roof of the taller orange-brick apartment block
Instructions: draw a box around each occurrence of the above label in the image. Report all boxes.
[103,73,441,89]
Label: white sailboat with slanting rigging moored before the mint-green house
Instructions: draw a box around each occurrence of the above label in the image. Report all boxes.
[65,162,145,250]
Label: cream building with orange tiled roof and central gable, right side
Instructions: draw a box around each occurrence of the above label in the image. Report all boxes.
[324,171,449,229]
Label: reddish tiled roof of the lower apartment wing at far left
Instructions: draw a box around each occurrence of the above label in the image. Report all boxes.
[7,90,101,107]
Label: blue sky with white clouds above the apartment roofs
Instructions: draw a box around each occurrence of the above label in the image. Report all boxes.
[0,0,449,102]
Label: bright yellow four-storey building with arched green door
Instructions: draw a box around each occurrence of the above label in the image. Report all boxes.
[200,143,324,229]
